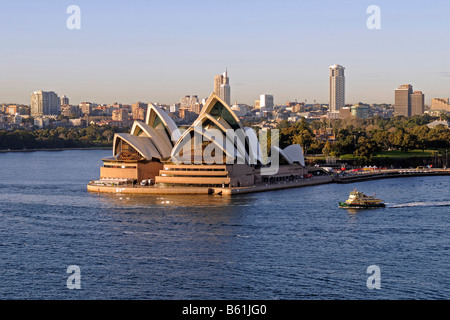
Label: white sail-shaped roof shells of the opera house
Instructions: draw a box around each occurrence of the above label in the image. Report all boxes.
[113,93,305,166]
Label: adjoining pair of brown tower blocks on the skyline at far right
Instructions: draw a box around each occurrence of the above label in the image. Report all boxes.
[394,84,425,117]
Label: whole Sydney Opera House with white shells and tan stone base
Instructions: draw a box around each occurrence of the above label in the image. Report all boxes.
[88,93,308,194]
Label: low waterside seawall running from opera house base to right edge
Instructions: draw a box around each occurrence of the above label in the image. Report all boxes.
[87,169,450,195]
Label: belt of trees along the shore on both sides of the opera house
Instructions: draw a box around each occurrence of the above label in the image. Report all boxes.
[0,114,450,163]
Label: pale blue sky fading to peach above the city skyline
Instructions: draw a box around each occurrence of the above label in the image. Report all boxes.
[0,0,450,104]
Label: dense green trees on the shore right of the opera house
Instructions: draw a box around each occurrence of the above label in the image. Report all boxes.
[270,114,450,163]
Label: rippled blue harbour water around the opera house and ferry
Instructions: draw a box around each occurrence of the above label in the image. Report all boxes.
[0,150,450,300]
